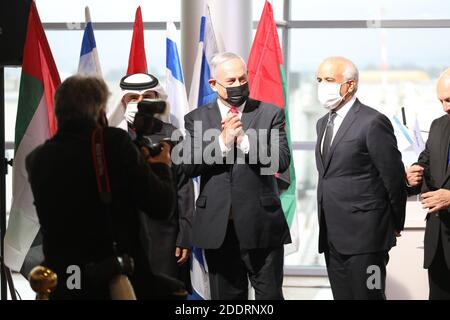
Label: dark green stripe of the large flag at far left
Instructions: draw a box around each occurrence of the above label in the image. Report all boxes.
[15,71,44,151]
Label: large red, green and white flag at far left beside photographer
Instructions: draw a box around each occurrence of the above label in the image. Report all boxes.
[5,1,61,271]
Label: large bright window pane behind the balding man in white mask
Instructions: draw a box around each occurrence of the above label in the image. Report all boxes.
[289,29,450,141]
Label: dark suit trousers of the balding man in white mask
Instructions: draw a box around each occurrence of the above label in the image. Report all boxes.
[325,243,389,300]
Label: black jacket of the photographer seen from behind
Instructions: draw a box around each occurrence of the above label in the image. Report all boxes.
[26,121,175,299]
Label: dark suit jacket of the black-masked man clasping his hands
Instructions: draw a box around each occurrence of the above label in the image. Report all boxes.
[183,99,291,249]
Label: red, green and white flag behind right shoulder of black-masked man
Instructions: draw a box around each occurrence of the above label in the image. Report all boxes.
[247,1,298,254]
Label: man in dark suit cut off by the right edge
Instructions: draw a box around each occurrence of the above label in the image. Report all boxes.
[407,69,450,300]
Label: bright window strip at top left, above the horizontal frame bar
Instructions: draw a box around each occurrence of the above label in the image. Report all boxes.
[36,0,181,22]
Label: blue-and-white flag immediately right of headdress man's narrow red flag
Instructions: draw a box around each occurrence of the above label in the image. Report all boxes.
[166,22,189,132]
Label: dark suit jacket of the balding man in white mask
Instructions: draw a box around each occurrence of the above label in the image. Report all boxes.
[316,100,406,255]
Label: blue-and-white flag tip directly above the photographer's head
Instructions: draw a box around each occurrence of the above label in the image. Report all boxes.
[78,7,102,78]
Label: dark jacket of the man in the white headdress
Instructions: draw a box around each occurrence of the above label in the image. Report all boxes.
[137,119,195,288]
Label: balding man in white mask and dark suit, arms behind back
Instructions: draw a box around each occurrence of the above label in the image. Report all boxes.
[316,57,406,300]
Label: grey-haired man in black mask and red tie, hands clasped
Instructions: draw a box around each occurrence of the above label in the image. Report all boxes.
[179,52,290,300]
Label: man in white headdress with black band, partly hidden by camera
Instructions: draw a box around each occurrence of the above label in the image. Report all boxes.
[109,73,195,291]
